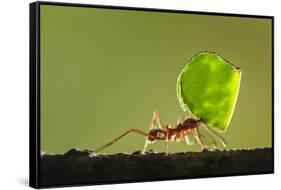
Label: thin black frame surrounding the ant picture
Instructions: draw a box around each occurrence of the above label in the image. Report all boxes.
[29,1,274,188]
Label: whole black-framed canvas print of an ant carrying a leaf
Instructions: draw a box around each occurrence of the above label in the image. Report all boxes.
[30,2,274,188]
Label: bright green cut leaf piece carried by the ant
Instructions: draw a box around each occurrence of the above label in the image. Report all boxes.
[177,52,241,131]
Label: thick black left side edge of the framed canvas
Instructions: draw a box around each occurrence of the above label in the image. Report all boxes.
[29,2,40,188]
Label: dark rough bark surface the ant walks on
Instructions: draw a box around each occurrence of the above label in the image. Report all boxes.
[40,148,273,187]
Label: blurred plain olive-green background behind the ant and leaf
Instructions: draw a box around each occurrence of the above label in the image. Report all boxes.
[40,5,272,154]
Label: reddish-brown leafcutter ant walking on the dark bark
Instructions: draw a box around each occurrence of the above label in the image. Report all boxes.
[95,112,226,155]
